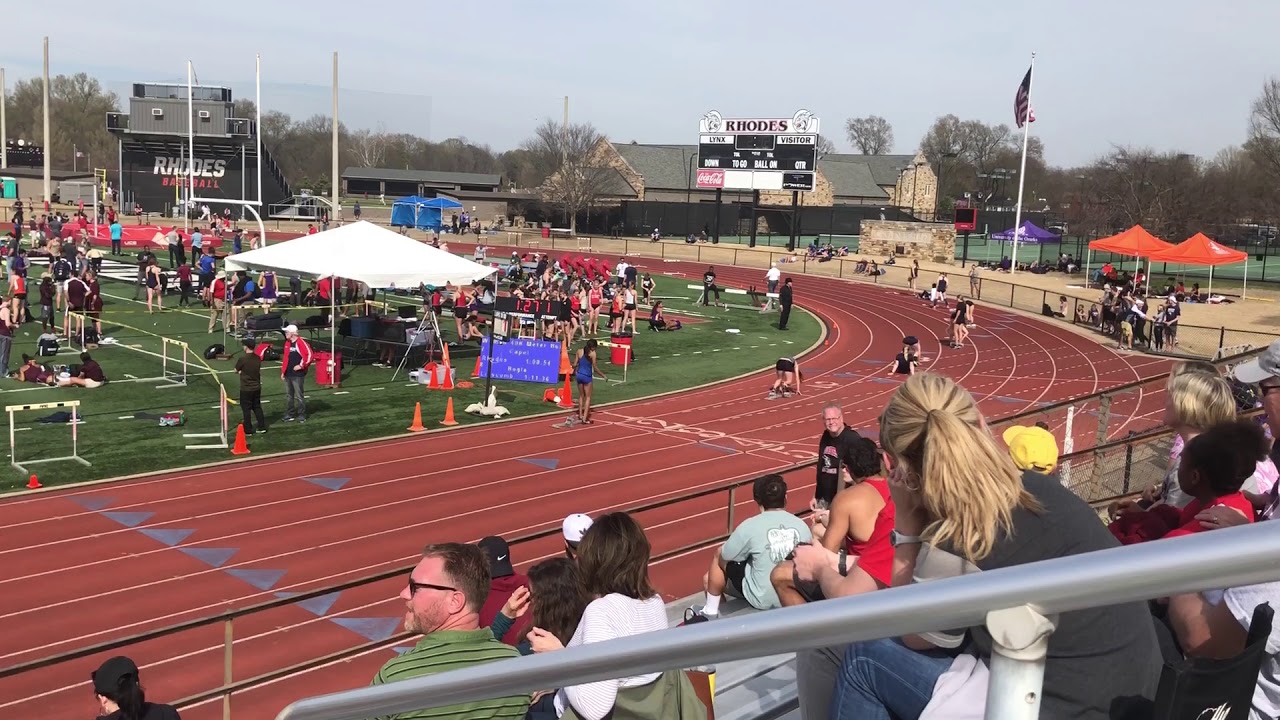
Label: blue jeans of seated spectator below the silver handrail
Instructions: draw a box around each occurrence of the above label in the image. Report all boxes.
[831,638,951,720]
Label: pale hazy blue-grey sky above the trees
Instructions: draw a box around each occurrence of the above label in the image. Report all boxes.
[0,0,1280,167]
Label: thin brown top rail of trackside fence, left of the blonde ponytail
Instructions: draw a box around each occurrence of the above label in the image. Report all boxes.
[0,460,817,678]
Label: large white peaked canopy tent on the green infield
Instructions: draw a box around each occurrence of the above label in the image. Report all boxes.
[225,220,497,378]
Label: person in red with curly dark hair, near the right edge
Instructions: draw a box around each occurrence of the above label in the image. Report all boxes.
[1108,420,1267,544]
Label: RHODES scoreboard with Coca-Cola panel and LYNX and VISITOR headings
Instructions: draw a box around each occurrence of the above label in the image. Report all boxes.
[696,110,819,191]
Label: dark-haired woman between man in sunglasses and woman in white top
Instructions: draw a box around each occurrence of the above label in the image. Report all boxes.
[492,557,591,655]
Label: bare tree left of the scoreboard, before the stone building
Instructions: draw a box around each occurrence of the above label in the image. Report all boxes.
[526,119,613,232]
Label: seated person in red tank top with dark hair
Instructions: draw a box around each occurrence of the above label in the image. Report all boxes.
[772,437,895,606]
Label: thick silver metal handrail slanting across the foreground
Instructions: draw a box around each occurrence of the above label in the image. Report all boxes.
[276,523,1280,720]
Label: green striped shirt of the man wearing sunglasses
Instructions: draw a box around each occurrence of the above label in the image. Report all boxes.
[372,628,530,720]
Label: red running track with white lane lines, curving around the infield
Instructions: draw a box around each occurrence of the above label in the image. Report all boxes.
[0,249,1167,719]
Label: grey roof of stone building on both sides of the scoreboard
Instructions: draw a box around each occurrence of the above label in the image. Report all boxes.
[611,142,915,199]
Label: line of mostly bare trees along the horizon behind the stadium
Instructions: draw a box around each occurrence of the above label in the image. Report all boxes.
[5,73,1280,241]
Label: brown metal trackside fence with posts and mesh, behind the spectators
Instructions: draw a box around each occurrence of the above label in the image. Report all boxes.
[0,350,1261,717]
